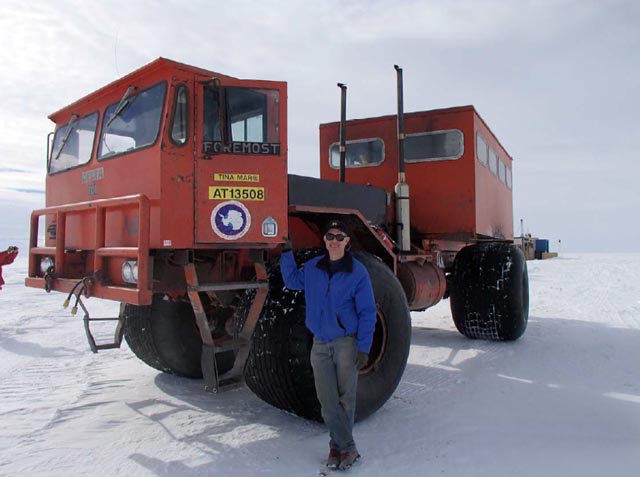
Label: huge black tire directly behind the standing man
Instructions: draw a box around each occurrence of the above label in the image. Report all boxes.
[245,250,411,421]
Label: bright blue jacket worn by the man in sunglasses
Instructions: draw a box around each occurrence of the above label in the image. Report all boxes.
[280,251,376,353]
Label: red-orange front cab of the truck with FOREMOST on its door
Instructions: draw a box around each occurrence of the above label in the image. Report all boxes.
[27,58,287,305]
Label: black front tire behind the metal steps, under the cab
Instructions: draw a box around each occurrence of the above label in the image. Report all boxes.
[122,294,235,378]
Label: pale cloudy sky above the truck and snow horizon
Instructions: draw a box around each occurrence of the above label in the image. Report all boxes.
[0,0,640,253]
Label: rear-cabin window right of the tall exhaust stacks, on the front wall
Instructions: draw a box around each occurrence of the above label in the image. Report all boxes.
[404,129,464,162]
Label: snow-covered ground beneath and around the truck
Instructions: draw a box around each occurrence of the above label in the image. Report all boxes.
[0,253,640,477]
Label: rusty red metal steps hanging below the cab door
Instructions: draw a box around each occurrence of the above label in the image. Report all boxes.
[184,261,269,393]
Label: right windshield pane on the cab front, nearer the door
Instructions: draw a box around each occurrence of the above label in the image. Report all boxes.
[98,83,166,159]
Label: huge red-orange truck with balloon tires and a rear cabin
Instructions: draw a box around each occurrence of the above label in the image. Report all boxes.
[26,58,529,419]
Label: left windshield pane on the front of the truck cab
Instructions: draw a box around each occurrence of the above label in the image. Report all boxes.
[49,112,98,174]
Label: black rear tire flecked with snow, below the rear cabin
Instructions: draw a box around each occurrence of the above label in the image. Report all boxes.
[450,242,529,341]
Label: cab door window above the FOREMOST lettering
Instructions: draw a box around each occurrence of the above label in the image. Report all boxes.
[203,87,280,154]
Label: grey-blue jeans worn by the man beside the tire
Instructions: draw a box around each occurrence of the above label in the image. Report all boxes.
[311,336,358,452]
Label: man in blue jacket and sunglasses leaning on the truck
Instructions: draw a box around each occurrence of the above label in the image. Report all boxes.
[280,221,376,470]
